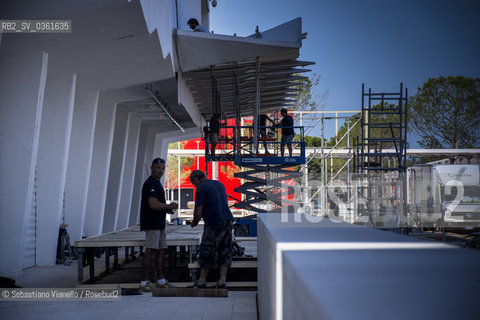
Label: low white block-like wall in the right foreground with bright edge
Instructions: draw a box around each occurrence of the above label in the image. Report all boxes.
[258,213,480,320]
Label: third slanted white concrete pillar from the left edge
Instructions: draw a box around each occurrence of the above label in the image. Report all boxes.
[65,91,98,245]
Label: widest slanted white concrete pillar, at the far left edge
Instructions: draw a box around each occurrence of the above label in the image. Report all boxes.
[0,52,48,278]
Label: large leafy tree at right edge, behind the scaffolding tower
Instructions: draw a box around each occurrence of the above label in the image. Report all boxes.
[409,76,480,149]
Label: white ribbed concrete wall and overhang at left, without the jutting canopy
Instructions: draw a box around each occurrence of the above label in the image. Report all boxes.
[0,0,201,278]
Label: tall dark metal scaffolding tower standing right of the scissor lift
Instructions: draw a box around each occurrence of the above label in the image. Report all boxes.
[355,83,408,229]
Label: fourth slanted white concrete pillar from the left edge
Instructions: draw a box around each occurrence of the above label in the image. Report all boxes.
[84,92,117,236]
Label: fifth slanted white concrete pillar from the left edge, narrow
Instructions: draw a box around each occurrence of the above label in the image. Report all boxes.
[102,105,129,233]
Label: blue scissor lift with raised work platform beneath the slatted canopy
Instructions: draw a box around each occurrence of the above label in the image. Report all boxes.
[206,126,305,213]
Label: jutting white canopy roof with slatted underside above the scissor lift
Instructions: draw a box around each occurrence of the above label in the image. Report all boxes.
[174,18,313,119]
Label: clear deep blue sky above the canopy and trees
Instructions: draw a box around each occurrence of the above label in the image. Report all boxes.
[210,0,480,144]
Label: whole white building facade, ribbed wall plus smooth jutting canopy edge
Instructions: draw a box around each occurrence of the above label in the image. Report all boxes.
[0,0,308,278]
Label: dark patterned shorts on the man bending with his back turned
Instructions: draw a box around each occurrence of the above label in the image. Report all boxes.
[199,221,233,269]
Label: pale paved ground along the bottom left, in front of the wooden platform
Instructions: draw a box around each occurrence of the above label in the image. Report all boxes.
[0,261,257,320]
